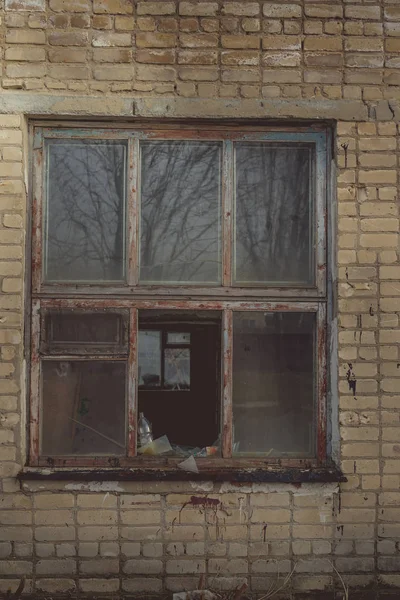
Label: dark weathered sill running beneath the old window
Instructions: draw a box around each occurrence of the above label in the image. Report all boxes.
[17,465,347,484]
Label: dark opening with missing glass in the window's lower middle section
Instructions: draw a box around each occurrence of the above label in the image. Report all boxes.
[138,311,221,456]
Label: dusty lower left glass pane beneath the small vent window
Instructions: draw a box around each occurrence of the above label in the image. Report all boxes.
[41,361,125,456]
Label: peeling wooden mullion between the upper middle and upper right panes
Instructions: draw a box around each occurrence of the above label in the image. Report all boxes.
[221,140,233,287]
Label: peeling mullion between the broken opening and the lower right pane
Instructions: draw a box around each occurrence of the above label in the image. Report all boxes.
[221,310,233,458]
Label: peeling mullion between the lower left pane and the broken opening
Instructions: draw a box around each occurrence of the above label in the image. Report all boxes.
[127,308,138,456]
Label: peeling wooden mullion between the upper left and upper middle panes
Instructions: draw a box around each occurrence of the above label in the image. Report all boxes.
[130,136,140,286]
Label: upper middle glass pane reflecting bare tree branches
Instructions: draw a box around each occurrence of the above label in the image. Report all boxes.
[140,141,222,283]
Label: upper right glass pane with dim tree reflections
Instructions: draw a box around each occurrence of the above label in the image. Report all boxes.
[234,143,314,285]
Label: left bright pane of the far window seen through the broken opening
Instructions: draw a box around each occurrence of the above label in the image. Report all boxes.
[138,330,161,387]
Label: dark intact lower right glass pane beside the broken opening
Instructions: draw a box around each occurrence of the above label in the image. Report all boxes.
[233,312,315,456]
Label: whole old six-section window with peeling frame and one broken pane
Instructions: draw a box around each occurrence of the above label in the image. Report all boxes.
[30,123,329,472]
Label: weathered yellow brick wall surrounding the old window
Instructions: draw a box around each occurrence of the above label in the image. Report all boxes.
[0,0,400,599]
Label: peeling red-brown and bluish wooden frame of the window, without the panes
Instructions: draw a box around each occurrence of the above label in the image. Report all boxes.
[28,122,331,478]
